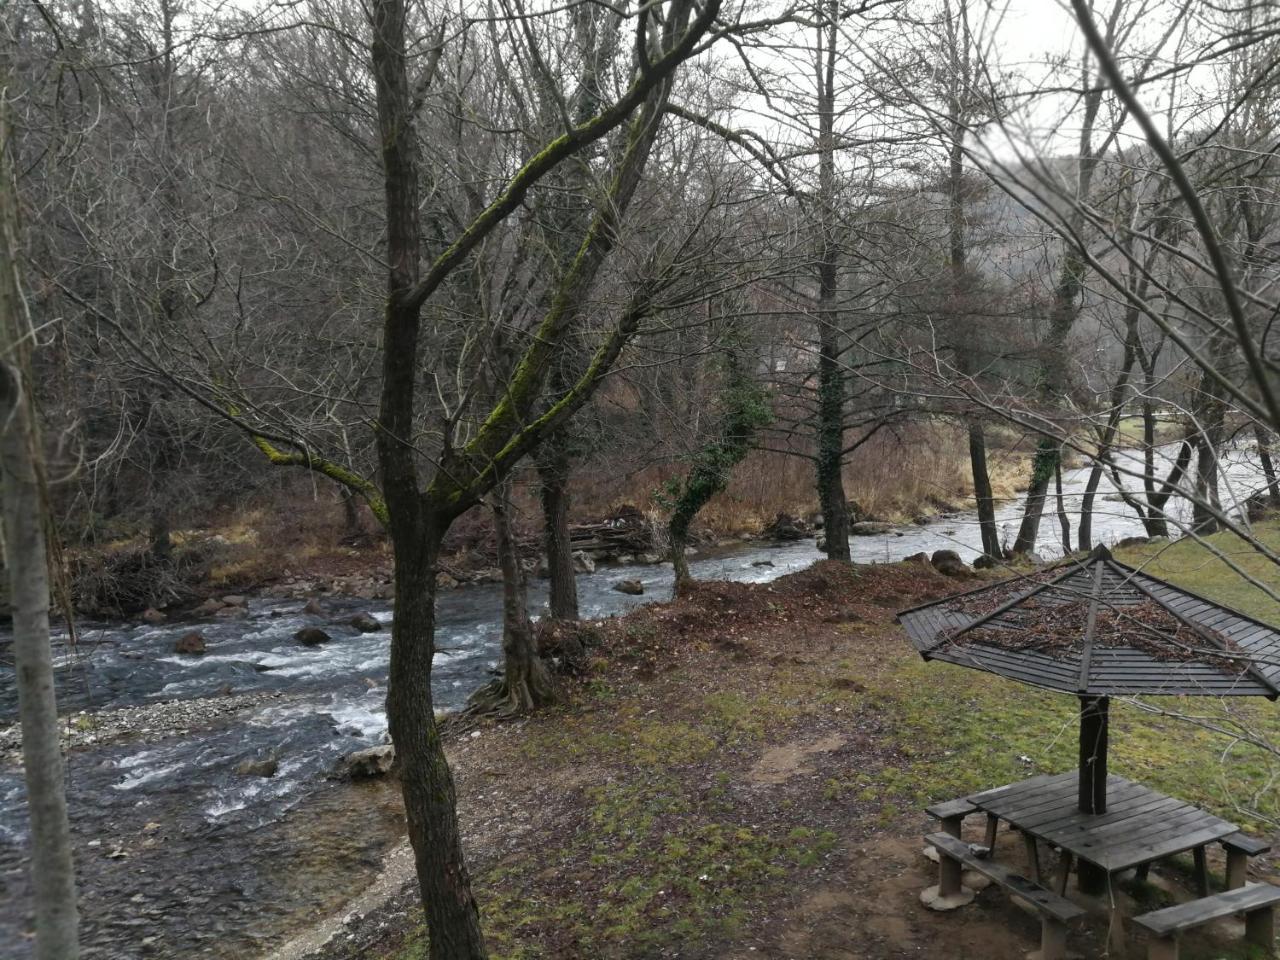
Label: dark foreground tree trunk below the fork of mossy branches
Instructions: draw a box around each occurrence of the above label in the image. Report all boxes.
[387,527,488,960]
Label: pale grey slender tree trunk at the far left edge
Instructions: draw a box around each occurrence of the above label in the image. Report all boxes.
[0,82,79,960]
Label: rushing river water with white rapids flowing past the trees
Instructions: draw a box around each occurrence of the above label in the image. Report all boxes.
[0,448,1260,960]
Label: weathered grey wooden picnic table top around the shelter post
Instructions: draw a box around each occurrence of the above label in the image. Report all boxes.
[965,771,1239,873]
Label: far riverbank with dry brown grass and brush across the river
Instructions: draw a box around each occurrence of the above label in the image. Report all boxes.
[65,421,1034,622]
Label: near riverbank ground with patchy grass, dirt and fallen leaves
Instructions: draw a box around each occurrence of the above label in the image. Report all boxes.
[285,521,1280,960]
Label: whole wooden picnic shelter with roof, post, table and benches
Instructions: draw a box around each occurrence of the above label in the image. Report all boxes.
[897,547,1280,942]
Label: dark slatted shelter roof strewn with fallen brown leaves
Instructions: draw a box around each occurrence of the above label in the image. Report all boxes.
[897,548,1280,700]
